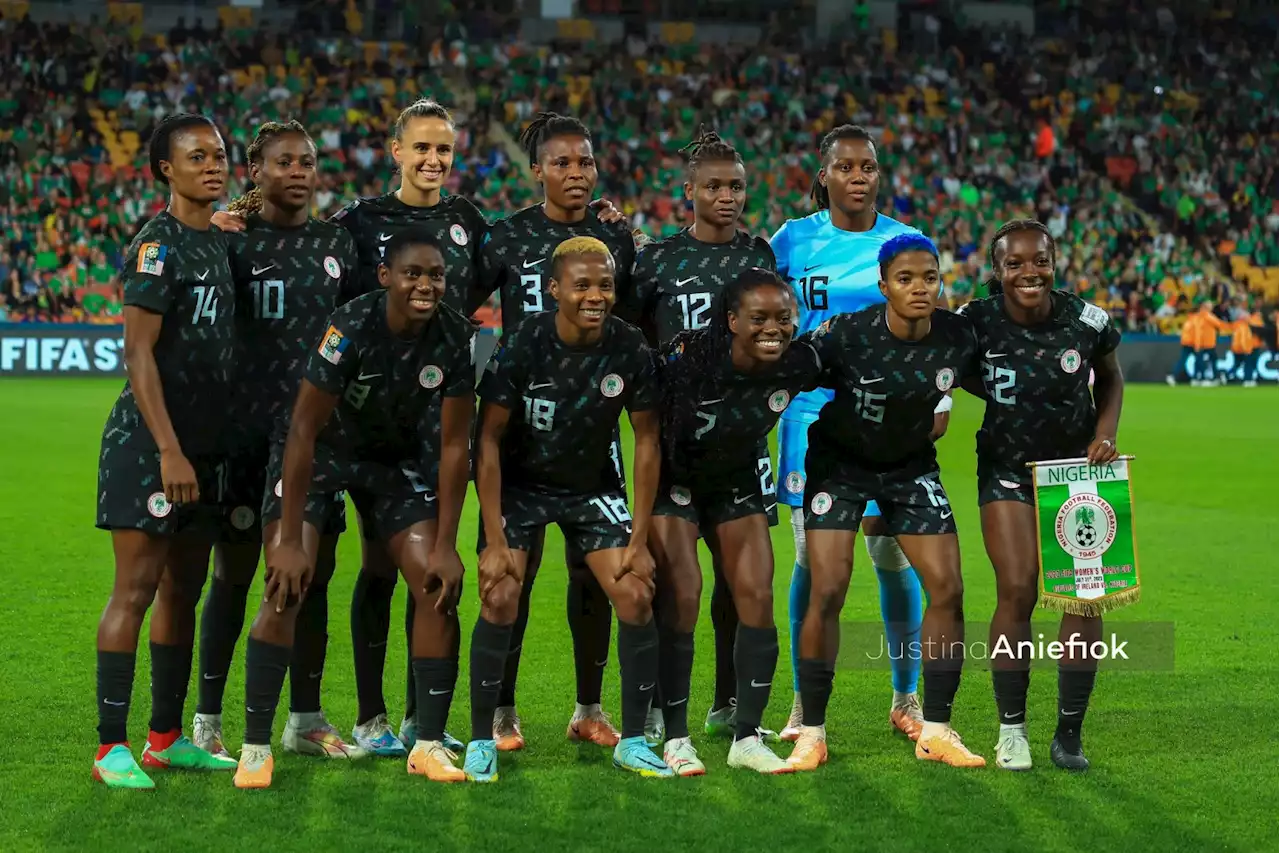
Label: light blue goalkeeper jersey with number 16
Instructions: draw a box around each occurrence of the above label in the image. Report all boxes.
[769,210,920,421]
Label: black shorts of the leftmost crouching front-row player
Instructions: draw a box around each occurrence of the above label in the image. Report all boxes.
[262,444,438,542]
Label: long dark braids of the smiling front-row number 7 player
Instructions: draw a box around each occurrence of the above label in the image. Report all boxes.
[659,266,791,460]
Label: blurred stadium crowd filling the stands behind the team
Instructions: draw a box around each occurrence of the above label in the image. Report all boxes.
[0,10,1280,332]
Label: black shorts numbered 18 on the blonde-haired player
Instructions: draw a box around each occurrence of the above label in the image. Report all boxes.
[476,487,631,558]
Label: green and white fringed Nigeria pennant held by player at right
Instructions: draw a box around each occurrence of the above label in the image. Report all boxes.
[1028,456,1142,616]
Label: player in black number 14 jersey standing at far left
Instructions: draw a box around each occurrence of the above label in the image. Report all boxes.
[93,114,236,789]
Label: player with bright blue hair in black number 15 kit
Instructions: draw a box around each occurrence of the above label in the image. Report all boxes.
[787,234,986,770]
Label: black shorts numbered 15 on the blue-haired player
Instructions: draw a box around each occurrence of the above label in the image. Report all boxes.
[804,462,956,535]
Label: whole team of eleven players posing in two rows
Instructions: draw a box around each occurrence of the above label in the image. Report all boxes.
[85,83,1124,789]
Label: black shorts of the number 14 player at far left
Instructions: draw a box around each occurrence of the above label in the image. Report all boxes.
[96,442,227,539]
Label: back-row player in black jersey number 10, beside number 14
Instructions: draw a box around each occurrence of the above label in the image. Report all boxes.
[192,122,358,758]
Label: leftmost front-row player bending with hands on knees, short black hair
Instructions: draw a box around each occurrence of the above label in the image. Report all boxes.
[236,233,475,788]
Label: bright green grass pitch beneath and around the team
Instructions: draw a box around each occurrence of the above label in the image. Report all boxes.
[0,380,1280,853]
